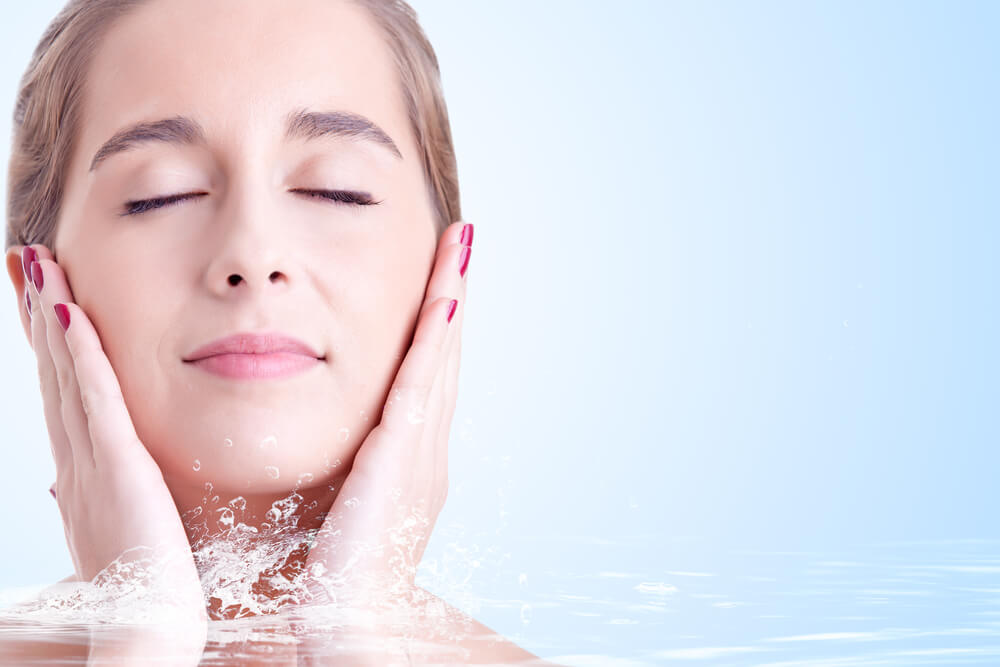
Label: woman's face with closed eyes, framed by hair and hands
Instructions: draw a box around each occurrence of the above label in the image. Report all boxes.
[48,0,437,493]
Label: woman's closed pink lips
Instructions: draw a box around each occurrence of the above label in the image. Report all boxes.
[184,333,326,379]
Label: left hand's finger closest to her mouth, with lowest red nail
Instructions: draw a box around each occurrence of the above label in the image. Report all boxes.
[61,303,148,472]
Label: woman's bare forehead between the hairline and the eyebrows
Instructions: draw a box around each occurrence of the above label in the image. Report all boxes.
[79,0,413,168]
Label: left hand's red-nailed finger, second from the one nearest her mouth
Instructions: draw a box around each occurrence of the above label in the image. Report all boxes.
[32,253,94,467]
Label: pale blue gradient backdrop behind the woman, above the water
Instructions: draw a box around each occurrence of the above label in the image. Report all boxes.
[0,0,1000,648]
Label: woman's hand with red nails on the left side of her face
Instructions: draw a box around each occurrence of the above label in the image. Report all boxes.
[22,245,207,619]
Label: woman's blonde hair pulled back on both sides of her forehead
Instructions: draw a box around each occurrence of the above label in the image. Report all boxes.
[5,0,461,249]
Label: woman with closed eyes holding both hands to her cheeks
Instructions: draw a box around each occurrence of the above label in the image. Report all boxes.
[6,0,533,661]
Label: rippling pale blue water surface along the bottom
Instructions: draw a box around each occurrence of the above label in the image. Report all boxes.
[0,526,1000,666]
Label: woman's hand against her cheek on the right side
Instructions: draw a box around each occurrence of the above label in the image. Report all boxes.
[306,222,472,607]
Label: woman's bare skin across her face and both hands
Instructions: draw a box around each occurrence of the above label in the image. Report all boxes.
[1,0,556,664]
